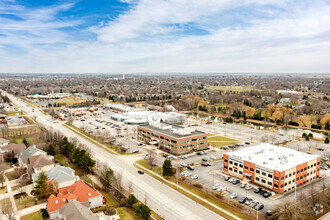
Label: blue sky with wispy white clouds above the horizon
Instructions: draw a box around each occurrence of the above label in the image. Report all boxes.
[0,0,330,73]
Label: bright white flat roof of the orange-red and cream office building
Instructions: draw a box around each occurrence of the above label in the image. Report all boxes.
[227,143,319,171]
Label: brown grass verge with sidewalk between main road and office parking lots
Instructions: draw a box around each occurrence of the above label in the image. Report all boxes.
[134,159,254,219]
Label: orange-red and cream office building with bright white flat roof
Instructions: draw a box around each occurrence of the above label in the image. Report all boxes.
[223,143,321,193]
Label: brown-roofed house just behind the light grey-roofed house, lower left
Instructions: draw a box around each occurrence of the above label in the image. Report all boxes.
[27,154,54,176]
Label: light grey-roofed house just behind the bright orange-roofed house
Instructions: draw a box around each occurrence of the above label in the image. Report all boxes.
[32,165,79,188]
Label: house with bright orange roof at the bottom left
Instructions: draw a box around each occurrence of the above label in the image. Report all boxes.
[47,180,106,219]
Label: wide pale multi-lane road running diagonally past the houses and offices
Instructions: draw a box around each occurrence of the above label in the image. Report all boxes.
[3,90,223,220]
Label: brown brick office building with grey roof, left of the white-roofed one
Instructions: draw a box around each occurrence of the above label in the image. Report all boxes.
[137,122,208,155]
